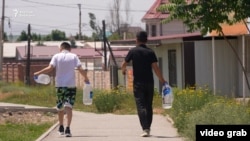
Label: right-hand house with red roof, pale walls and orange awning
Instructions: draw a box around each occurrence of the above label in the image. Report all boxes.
[111,0,250,97]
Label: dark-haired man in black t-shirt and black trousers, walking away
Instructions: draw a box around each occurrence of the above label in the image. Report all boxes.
[122,31,166,137]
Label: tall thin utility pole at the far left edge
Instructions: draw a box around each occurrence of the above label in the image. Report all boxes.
[0,0,5,81]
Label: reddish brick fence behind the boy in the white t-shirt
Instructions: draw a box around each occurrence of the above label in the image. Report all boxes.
[3,63,111,89]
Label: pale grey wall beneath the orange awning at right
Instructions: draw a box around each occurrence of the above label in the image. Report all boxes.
[195,40,239,96]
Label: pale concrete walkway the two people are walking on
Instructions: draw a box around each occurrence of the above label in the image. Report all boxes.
[0,103,184,141]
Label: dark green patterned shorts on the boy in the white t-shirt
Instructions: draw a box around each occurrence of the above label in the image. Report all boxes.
[56,87,76,110]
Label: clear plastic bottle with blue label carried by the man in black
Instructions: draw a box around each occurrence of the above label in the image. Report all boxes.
[162,83,174,109]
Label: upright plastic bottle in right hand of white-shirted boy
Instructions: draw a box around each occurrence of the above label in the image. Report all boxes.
[83,82,93,105]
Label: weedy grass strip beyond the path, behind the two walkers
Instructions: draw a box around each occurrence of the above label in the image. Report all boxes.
[0,84,164,114]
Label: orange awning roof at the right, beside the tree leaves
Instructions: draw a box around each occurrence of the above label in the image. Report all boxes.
[207,22,249,36]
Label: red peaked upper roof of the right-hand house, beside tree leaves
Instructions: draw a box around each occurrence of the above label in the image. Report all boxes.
[142,0,169,21]
